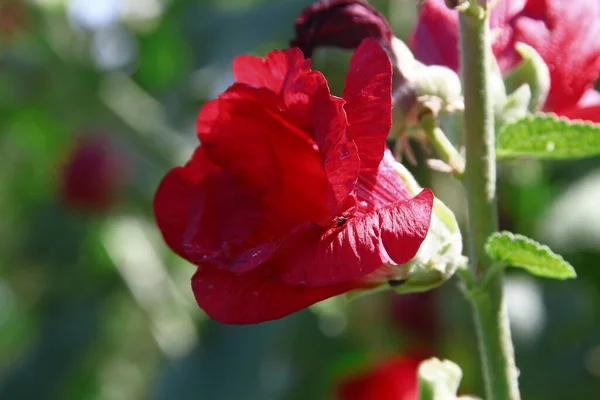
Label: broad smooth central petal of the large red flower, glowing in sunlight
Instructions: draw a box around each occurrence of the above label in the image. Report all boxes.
[198,84,328,227]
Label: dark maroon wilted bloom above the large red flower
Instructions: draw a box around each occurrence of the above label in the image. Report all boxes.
[290,0,393,57]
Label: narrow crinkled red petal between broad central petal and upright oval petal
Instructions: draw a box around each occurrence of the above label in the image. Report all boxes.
[313,85,360,216]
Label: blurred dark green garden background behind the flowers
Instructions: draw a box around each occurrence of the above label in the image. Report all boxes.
[0,0,600,400]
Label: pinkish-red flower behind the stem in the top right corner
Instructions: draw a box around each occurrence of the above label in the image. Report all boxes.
[412,0,600,122]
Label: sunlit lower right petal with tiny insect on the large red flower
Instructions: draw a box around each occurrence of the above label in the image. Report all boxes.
[281,189,433,286]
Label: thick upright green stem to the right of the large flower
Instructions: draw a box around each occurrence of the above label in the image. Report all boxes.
[460,3,520,400]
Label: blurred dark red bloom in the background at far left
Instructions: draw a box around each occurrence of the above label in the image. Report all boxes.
[60,135,129,212]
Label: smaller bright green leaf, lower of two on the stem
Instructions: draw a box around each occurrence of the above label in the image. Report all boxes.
[485,232,577,279]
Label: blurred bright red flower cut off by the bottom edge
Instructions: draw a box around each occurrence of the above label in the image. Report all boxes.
[336,356,423,400]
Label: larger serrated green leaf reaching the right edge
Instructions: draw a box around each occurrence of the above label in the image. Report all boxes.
[496,114,600,160]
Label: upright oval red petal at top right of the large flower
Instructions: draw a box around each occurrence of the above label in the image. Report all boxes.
[342,38,392,171]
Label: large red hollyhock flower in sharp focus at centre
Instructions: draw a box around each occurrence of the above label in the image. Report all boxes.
[154,39,433,324]
